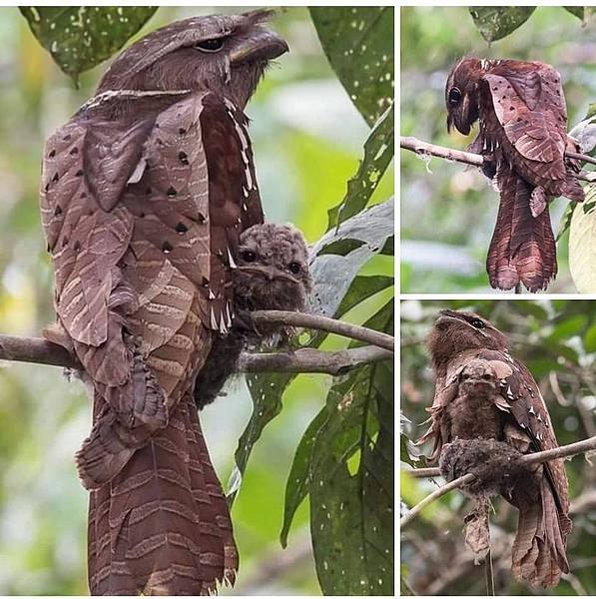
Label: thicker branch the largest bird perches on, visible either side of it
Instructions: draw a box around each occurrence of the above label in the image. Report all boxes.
[0,335,393,376]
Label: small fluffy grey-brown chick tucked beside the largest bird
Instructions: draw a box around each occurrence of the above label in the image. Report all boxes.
[194,223,312,408]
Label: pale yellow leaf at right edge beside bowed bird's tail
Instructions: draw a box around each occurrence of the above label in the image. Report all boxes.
[569,184,596,293]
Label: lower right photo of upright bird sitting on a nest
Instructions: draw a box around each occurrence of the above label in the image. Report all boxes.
[400,298,596,596]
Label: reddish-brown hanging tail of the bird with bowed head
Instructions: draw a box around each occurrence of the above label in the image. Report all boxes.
[486,164,557,292]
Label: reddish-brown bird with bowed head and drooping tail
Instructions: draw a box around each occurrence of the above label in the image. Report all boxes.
[445,58,584,291]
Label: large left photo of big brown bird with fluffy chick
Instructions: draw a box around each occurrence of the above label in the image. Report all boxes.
[0,5,397,597]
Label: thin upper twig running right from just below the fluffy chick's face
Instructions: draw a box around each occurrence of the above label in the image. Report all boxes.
[251,310,395,351]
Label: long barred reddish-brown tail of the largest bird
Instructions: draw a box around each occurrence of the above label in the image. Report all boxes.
[89,396,237,595]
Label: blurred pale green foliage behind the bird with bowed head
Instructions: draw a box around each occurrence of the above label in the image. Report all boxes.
[400,6,596,293]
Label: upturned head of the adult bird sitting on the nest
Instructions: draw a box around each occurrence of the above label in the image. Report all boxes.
[428,310,507,365]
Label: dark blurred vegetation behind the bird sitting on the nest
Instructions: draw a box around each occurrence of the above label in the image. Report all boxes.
[401,300,596,596]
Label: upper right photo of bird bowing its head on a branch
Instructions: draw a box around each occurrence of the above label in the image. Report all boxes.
[400,6,596,294]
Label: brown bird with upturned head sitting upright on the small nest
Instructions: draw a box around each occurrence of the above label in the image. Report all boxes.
[421,310,571,587]
